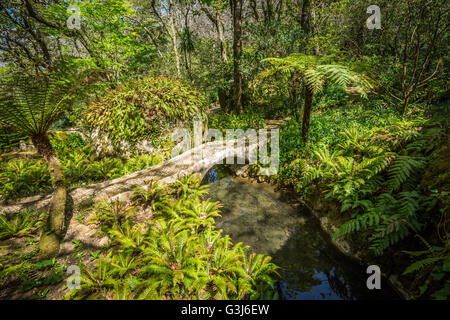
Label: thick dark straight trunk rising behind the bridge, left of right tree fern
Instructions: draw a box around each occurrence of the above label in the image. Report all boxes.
[230,0,242,112]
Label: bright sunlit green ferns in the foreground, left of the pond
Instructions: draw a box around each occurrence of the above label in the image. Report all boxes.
[0,176,276,300]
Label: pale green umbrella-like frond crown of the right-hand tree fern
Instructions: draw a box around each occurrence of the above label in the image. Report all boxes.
[260,53,372,96]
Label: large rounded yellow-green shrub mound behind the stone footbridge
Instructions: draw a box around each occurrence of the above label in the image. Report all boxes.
[82,77,206,144]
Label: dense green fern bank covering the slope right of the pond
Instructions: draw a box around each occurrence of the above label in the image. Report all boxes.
[277,107,450,299]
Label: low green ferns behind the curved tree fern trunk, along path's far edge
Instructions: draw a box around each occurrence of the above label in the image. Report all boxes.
[0,134,164,200]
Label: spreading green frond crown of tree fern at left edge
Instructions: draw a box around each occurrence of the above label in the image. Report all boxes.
[0,78,74,136]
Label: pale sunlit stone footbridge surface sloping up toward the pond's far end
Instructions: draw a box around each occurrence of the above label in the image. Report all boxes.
[0,135,264,214]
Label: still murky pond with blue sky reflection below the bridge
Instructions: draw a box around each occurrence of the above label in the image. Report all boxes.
[203,166,399,300]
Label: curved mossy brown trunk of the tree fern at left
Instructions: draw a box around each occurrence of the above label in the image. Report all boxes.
[32,134,67,259]
